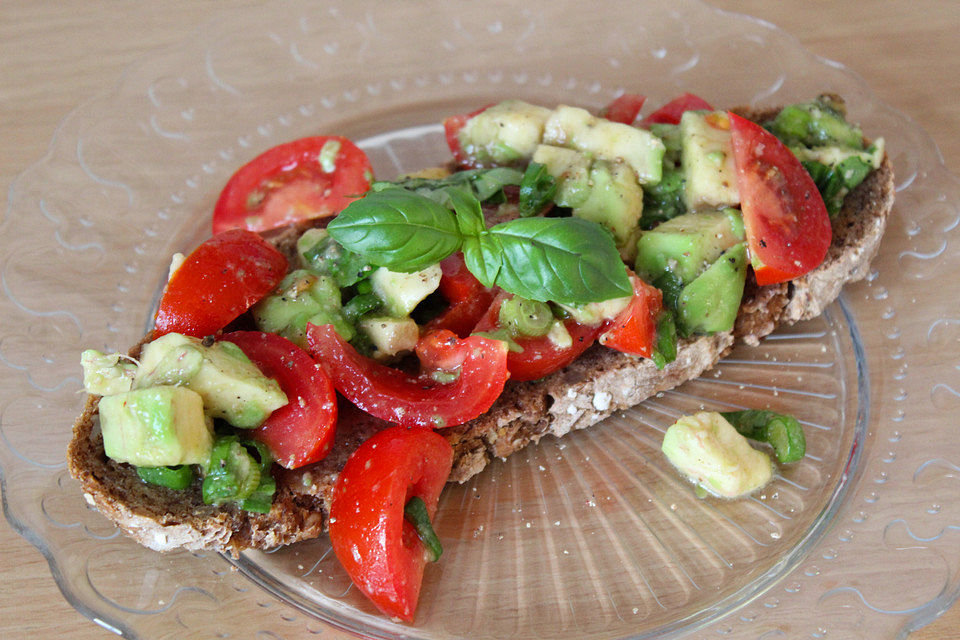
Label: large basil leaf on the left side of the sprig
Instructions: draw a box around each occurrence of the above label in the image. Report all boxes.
[327,187,462,273]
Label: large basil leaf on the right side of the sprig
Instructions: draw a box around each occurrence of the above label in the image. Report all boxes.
[464,218,633,305]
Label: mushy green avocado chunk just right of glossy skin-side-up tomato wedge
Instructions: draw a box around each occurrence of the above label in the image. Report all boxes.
[251,269,356,347]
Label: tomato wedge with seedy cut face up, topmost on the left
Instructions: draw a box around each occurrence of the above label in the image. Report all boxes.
[213,136,373,233]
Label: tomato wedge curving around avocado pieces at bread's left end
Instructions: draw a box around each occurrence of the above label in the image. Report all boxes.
[220,331,337,469]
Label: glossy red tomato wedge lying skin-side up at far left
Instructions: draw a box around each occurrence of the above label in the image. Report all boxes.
[154,229,287,338]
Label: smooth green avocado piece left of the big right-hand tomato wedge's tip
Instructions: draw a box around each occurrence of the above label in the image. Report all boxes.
[677,242,747,335]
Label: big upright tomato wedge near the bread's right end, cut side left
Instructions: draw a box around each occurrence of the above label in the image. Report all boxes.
[730,113,832,285]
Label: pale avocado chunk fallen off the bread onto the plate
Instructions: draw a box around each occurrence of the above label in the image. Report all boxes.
[661,411,773,498]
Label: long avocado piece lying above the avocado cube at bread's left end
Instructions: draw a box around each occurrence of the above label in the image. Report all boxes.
[134,333,287,428]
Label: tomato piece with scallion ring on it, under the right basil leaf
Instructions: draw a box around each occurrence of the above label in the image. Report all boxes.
[474,291,603,381]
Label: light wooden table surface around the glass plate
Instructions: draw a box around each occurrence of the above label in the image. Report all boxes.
[0,0,960,640]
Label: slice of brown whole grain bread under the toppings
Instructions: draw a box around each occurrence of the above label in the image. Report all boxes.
[68,109,894,554]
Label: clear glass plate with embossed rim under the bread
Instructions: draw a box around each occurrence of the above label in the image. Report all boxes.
[0,0,960,639]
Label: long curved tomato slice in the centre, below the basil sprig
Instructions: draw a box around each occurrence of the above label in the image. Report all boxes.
[307,324,508,428]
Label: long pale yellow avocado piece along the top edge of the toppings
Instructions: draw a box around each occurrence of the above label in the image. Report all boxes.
[543,105,665,184]
